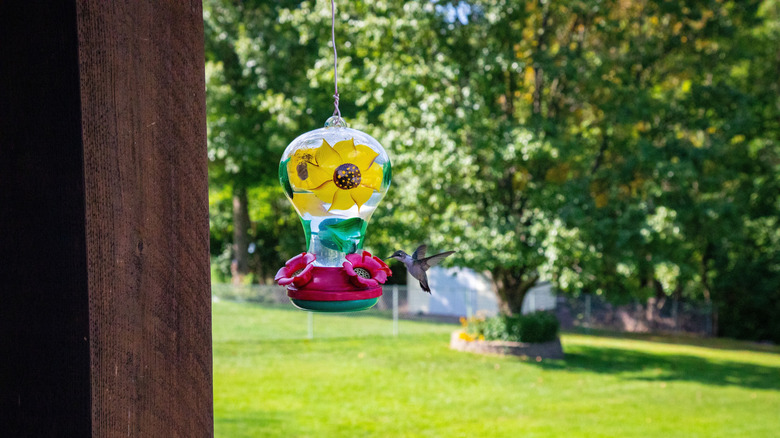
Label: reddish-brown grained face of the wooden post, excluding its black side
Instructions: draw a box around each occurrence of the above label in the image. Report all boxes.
[77,0,213,437]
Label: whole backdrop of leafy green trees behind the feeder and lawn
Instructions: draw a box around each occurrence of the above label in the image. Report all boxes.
[204,0,780,342]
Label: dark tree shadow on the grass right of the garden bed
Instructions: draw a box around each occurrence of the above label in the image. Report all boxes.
[530,346,780,390]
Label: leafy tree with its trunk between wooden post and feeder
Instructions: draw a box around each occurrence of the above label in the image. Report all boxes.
[204,0,317,279]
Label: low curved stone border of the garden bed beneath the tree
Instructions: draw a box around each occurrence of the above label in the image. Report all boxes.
[450,330,564,359]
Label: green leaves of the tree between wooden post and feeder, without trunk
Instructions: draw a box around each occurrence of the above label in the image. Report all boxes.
[203,0,326,282]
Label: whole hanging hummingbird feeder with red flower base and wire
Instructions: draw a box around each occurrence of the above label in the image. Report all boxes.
[274,2,392,312]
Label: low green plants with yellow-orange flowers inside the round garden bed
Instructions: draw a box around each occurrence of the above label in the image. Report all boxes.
[461,312,560,343]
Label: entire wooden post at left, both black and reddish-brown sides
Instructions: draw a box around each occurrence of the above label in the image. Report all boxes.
[0,0,213,437]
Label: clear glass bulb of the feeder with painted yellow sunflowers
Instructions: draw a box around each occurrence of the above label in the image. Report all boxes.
[279,116,392,267]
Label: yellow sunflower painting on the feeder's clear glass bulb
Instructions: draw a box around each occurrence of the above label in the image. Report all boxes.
[287,139,382,210]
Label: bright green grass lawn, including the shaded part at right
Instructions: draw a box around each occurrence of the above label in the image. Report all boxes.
[213,301,780,438]
